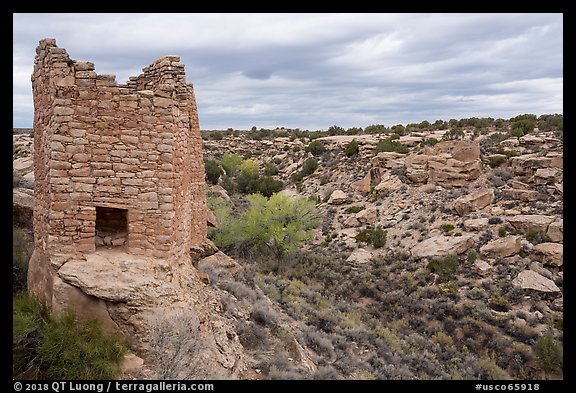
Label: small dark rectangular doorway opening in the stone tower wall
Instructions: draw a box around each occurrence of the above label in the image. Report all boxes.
[96,206,128,248]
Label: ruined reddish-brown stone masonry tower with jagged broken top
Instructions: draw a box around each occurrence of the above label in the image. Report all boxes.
[28,39,207,305]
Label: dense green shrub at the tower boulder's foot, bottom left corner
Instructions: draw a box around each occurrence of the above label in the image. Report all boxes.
[12,295,126,380]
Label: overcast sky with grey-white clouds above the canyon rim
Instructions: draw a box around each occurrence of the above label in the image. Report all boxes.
[13,13,564,130]
